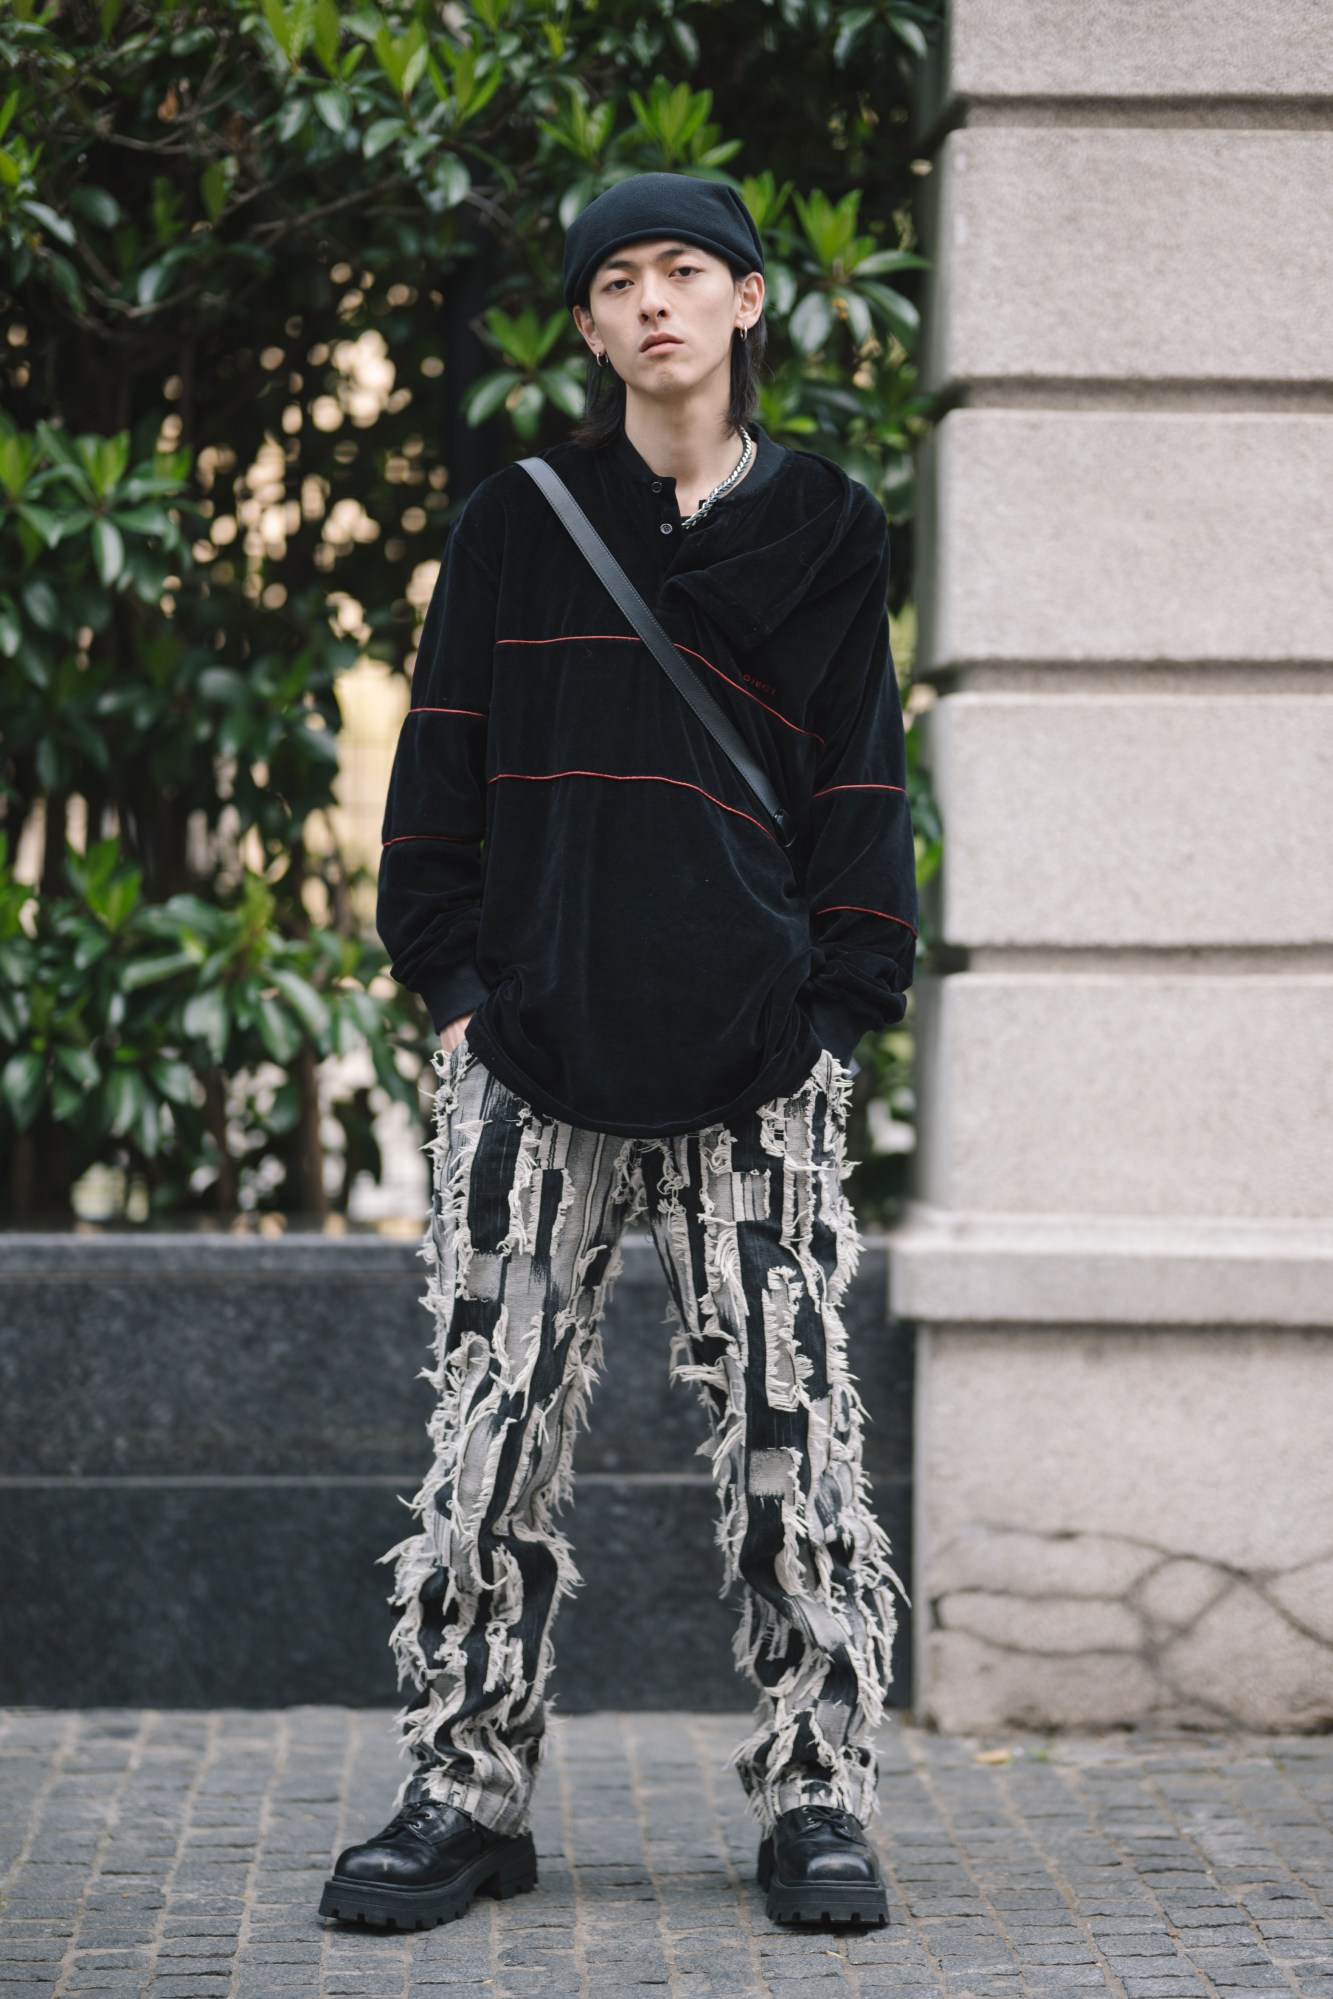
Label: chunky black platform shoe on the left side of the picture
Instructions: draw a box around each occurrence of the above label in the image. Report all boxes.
[320,1797,538,1929]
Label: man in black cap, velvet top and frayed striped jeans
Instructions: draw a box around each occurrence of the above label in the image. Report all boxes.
[320,174,917,1929]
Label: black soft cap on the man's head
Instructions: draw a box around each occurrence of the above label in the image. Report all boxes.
[564,174,763,306]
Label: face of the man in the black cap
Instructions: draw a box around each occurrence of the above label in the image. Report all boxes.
[574,236,763,396]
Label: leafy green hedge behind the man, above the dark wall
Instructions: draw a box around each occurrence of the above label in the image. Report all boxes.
[0,0,937,1219]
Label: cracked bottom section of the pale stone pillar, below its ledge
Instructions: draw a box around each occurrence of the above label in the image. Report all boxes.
[917,1327,1333,1729]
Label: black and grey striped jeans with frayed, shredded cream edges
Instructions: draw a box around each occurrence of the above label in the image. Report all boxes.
[380,1039,901,1833]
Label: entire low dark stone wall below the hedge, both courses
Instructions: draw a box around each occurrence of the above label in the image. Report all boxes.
[0,1229,913,1711]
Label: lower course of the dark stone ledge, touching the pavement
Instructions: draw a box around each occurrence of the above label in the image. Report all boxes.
[0,1473,911,1713]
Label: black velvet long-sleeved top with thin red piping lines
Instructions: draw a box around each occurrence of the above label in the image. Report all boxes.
[378,424,917,1137]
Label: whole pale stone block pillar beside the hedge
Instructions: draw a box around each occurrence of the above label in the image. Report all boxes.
[889,0,1333,1729]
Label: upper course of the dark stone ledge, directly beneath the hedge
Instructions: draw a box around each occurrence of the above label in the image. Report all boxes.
[0,1229,911,1477]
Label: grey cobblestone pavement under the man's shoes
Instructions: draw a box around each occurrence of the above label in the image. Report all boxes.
[0,1707,1333,1999]
